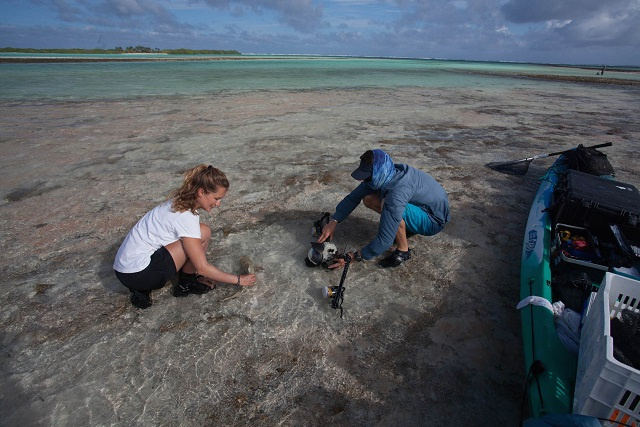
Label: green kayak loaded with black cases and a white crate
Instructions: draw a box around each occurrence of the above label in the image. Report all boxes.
[518,150,640,425]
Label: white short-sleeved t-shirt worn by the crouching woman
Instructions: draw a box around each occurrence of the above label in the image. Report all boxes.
[113,200,201,273]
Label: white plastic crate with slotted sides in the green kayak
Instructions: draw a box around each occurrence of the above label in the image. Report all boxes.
[573,273,640,427]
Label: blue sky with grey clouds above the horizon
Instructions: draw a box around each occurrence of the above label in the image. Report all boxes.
[0,0,640,65]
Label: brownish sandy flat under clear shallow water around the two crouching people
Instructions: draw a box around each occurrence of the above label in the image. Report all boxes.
[0,82,640,426]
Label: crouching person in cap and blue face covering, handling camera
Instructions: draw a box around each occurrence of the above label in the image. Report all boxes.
[318,150,450,268]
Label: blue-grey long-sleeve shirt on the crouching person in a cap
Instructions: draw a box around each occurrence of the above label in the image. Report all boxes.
[332,164,450,259]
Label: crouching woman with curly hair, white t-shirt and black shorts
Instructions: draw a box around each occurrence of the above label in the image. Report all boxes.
[113,165,256,308]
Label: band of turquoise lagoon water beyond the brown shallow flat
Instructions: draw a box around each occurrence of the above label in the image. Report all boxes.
[0,54,640,100]
